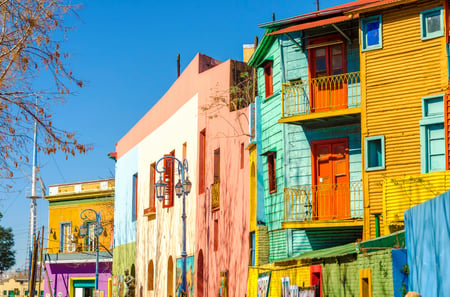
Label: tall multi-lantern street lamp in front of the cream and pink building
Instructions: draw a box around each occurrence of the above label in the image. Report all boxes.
[155,155,192,293]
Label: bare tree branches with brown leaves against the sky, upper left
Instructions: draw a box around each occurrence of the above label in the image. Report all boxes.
[0,0,91,187]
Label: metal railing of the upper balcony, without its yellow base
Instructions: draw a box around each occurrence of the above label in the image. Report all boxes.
[281,72,361,117]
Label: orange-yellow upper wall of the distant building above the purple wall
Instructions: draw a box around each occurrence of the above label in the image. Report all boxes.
[48,197,114,254]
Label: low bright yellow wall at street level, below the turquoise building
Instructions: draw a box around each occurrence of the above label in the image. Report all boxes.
[247,264,311,297]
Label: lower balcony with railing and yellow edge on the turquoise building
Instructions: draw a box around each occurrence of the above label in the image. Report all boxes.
[283,182,363,228]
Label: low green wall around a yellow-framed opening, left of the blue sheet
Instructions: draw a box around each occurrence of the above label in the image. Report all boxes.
[322,250,394,297]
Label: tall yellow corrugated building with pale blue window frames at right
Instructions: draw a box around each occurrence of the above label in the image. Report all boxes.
[356,0,450,239]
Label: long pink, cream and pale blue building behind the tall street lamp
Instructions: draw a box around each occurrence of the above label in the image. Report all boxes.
[114,54,255,296]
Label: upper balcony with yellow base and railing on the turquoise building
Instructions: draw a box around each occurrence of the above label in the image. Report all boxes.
[279,72,361,126]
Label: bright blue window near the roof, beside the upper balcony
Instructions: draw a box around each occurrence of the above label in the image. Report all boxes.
[361,15,383,51]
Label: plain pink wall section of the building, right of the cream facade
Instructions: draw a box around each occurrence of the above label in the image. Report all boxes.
[195,61,252,297]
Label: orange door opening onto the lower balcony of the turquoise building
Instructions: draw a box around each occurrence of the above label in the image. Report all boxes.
[311,138,350,220]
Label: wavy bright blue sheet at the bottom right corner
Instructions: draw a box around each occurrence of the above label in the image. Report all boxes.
[405,191,450,297]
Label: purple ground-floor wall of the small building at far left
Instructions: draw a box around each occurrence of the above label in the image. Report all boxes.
[44,262,112,297]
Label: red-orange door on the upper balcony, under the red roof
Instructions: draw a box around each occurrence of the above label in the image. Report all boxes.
[309,43,347,112]
